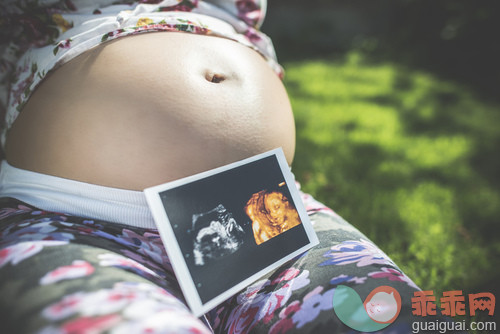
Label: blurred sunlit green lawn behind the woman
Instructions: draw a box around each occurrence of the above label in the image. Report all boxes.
[285,53,500,296]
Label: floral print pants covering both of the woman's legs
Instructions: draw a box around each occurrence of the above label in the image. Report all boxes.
[0,194,418,333]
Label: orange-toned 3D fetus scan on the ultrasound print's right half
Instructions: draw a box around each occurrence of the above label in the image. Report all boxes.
[245,190,301,245]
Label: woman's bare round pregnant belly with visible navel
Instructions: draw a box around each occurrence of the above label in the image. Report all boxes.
[6,32,295,190]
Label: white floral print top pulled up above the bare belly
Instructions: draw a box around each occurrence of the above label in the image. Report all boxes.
[0,0,282,145]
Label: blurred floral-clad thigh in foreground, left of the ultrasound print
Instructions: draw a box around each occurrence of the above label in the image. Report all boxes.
[0,201,210,333]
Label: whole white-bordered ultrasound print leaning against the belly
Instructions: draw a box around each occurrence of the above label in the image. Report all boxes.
[144,149,318,316]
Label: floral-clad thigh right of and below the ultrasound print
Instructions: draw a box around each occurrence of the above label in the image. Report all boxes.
[208,210,419,333]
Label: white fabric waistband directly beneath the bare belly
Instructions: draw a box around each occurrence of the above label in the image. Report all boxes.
[0,160,156,229]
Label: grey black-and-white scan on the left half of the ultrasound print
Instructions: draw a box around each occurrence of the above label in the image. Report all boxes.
[190,204,245,266]
